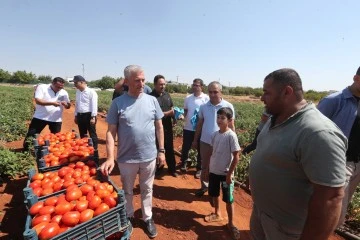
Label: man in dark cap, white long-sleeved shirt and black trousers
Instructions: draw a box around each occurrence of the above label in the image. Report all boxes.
[72,75,98,154]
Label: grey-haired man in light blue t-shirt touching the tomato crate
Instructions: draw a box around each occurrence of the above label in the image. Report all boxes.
[101,65,165,238]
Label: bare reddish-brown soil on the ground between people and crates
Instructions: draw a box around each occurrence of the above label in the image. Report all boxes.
[0,106,342,240]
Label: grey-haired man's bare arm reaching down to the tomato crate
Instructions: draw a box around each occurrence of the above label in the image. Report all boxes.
[100,124,117,176]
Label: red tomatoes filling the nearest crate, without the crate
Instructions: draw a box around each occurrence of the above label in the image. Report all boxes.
[29,175,118,239]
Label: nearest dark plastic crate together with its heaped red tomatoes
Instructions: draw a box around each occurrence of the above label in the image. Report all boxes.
[23,173,130,240]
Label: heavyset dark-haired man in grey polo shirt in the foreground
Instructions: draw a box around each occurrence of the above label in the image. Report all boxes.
[249,69,347,240]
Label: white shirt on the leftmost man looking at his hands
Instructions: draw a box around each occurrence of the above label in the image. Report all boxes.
[33,84,70,122]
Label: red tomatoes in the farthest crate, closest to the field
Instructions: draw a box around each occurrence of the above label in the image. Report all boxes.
[38,137,94,167]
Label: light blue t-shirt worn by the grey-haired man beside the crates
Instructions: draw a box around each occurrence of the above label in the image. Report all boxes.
[106,92,164,163]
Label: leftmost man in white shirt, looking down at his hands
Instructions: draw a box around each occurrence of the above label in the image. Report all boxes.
[23,77,70,150]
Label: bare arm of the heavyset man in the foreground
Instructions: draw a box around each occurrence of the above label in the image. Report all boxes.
[300,184,344,240]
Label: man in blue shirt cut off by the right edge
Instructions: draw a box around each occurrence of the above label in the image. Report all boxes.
[318,67,360,227]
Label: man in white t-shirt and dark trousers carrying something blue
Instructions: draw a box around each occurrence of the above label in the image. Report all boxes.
[181,78,209,178]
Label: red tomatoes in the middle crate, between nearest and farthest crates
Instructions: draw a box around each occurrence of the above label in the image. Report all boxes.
[29,160,96,197]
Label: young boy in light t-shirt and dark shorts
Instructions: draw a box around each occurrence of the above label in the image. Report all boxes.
[205,107,240,239]
